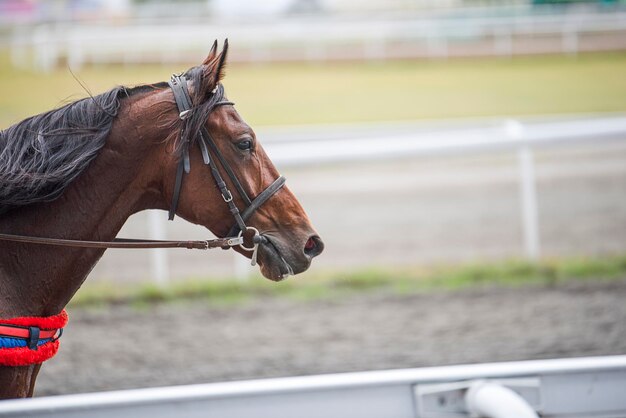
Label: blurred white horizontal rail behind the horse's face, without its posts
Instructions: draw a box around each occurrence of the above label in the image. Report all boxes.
[258,114,626,167]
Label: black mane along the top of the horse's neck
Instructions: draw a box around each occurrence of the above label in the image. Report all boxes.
[0,87,140,214]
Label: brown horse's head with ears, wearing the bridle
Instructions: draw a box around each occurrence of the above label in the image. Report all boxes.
[158,41,324,281]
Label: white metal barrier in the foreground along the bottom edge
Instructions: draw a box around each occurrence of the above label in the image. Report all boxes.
[0,356,626,418]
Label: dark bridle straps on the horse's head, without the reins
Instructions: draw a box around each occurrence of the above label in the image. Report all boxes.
[168,75,285,248]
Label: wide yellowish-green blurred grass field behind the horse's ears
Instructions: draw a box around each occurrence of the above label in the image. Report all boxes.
[0,53,626,128]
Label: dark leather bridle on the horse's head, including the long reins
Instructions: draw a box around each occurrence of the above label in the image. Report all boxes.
[0,74,286,265]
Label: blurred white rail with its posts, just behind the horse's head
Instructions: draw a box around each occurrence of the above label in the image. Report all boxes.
[145,114,626,283]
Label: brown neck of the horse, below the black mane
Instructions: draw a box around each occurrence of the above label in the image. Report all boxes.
[0,90,171,317]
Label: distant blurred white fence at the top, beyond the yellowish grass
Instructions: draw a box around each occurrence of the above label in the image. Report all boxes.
[11,9,626,71]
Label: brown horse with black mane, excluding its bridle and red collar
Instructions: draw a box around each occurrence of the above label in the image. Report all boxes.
[0,43,323,398]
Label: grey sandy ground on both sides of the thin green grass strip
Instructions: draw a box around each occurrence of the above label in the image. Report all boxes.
[31,131,626,395]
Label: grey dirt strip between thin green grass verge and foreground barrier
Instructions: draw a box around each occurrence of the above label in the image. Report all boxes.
[37,278,626,395]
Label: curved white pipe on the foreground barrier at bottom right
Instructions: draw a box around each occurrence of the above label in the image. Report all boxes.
[465,380,539,418]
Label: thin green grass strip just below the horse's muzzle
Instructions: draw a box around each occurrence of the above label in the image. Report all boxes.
[71,255,626,307]
